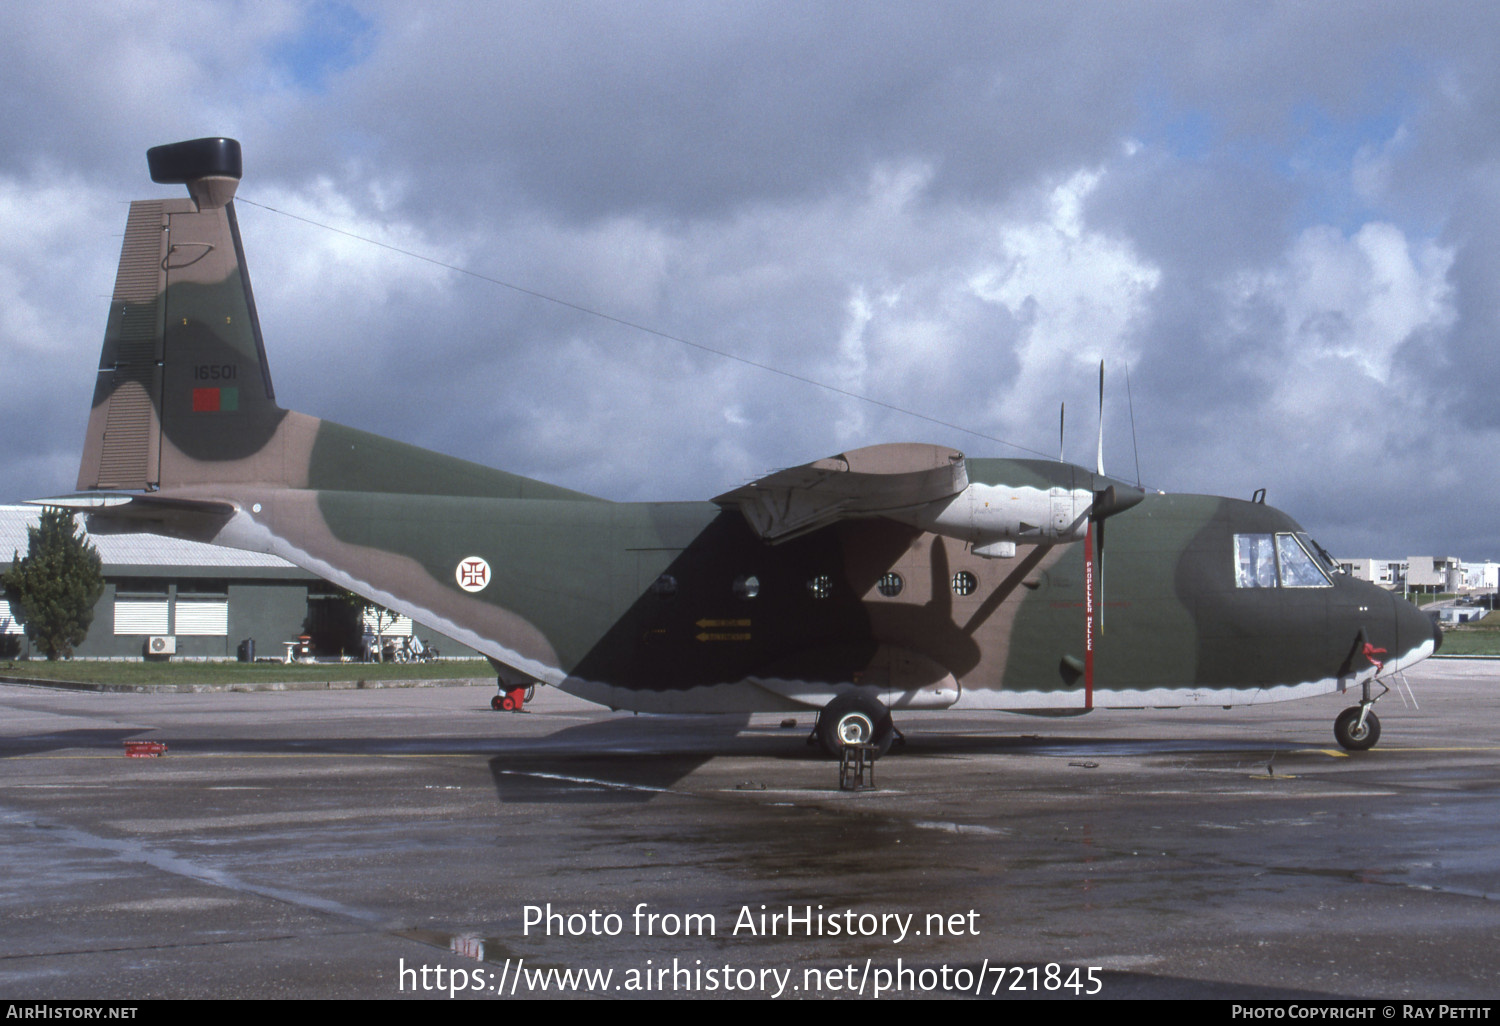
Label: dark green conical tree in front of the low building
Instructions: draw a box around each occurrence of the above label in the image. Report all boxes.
[0,509,104,659]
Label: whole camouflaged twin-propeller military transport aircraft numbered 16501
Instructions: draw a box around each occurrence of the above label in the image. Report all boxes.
[41,138,1442,753]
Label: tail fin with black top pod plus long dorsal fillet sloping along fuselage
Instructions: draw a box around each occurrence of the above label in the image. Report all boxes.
[78,138,590,510]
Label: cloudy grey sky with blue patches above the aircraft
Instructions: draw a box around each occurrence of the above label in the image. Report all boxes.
[0,0,1500,560]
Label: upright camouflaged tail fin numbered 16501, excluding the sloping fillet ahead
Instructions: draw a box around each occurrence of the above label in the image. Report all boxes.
[78,138,285,489]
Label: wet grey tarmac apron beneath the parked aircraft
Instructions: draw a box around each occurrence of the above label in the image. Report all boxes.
[0,660,1500,999]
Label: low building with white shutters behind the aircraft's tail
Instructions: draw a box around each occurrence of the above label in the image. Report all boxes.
[0,506,479,659]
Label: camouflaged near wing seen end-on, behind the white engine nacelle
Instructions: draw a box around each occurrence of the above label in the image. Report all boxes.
[714,443,969,543]
